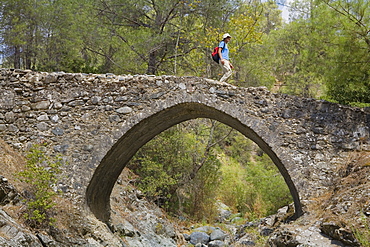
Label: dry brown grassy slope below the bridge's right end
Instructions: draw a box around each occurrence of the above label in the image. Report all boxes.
[309,151,370,230]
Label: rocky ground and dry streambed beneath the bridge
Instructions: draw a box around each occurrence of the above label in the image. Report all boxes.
[0,138,370,247]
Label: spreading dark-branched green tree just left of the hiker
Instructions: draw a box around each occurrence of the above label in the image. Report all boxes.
[94,0,249,75]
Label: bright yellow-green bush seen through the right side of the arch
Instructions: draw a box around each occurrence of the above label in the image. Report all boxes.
[220,151,292,220]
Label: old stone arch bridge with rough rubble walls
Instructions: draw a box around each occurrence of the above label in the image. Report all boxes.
[0,69,370,222]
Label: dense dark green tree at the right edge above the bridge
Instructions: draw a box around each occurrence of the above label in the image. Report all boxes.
[322,0,370,105]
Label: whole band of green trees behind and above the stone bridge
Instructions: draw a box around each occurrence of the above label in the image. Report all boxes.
[0,0,370,106]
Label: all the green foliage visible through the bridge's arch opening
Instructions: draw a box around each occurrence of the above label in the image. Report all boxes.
[129,120,292,222]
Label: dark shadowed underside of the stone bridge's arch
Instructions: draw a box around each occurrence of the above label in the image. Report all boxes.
[86,103,303,223]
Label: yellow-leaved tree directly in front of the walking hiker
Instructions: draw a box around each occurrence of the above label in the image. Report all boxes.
[228,1,282,86]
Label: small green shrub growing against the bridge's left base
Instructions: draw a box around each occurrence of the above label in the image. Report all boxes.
[16,145,62,228]
